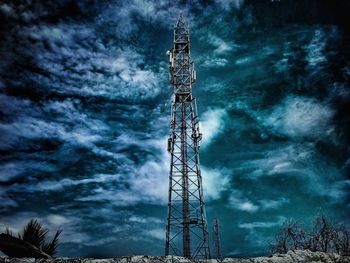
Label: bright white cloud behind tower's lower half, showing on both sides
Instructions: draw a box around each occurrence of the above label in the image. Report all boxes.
[72,133,229,205]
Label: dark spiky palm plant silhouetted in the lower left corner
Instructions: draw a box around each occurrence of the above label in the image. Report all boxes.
[1,219,62,256]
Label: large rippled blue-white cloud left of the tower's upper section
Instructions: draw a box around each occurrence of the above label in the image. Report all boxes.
[21,21,166,101]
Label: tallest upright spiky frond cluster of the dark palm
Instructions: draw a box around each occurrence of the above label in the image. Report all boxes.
[21,219,48,248]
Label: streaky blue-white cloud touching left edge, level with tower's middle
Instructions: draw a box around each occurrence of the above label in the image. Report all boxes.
[0,99,108,152]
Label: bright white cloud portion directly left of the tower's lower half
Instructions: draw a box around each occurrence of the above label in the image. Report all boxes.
[38,139,169,207]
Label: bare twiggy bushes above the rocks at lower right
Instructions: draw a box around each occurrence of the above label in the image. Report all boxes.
[271,214,350,255]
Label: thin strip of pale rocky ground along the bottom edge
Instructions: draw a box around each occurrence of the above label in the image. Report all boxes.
[0,250,350,263]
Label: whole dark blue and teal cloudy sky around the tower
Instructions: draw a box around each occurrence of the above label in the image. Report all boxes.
[0,0,350,257]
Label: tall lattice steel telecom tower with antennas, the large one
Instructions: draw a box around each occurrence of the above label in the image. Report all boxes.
[165,14,210,259]
